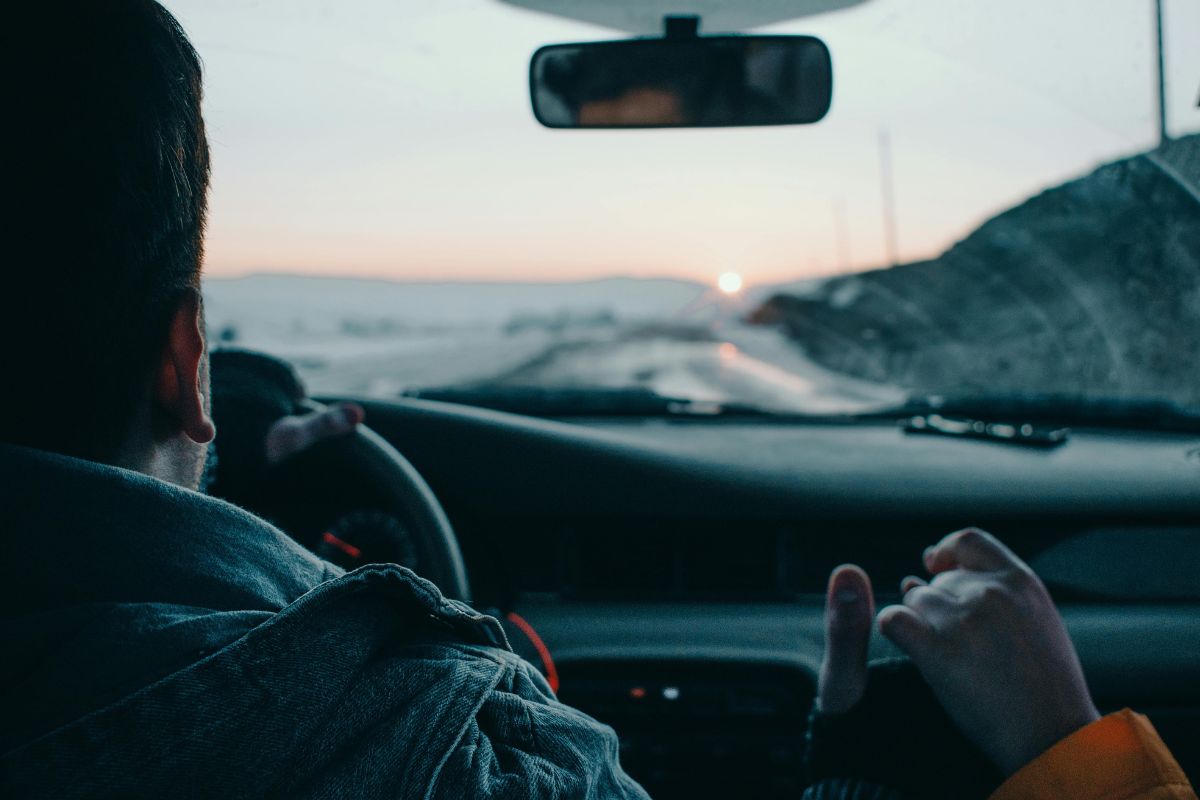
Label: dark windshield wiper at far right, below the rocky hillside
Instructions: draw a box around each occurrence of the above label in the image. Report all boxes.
[889,395,1200,434]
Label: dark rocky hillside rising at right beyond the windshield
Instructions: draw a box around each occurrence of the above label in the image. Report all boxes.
[750,134,1200,404]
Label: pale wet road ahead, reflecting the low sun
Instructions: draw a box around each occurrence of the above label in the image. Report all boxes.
[258,323,902,414]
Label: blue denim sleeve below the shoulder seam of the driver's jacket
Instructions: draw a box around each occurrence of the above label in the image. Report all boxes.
[428,654,648,800]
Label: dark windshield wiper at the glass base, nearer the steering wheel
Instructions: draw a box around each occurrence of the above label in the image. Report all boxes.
[402,384,770,417]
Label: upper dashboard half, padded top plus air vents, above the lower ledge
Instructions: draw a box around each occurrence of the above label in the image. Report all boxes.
[345,401,1200,604]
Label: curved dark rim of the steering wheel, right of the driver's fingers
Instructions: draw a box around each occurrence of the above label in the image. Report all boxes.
[302,401,470,601]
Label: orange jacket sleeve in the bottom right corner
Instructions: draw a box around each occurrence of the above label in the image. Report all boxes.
[991,709,1196,800]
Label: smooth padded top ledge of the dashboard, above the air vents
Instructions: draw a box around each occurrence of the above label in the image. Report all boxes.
[366,401,1200,518]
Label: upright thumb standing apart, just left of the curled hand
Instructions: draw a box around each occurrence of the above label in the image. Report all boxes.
[817,564,875,714]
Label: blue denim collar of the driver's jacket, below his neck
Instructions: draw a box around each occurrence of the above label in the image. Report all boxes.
[0,444,341,614]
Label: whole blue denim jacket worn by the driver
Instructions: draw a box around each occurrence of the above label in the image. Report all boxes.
[0,445,646,799]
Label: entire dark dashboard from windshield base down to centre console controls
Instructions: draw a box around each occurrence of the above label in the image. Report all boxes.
[270,401,1200,798]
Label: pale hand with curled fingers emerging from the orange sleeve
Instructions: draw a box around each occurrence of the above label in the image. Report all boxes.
[878,529,1099,775]
